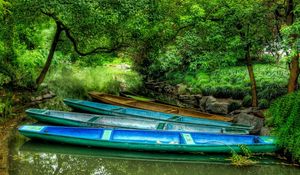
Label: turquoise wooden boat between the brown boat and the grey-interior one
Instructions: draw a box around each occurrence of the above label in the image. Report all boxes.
[64,99,252,130]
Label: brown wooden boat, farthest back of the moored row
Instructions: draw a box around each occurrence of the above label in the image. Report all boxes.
[89,92,232,121]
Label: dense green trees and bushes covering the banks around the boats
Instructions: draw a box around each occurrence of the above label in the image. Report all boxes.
[0,0,300,165]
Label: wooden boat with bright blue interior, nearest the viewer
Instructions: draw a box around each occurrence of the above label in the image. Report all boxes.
[19,125,277,153]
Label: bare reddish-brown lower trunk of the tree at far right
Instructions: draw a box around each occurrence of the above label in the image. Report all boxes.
[288,54,300,93]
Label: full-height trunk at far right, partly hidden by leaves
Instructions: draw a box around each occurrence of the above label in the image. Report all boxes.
[286,0,299,93]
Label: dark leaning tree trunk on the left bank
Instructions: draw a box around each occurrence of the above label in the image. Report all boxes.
[36,22,63,86]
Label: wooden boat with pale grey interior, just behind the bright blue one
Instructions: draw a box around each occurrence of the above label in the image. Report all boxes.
[26,109,249,134]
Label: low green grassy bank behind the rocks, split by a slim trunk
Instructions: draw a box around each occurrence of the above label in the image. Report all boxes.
[166,64,289,108]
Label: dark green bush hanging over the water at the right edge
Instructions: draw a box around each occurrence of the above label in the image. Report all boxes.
[267,91,300,161]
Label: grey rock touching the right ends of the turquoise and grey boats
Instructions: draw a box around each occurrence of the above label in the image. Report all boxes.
[233,113,264,134]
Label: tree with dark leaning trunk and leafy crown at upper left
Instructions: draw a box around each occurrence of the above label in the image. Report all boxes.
[14,0,135,85]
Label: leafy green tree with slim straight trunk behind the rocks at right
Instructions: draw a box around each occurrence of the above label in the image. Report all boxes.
[197,0,273,107]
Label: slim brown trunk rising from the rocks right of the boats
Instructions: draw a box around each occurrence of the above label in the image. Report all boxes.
[245,44,258,107]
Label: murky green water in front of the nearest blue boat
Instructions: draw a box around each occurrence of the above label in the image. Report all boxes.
[9,132,300,175]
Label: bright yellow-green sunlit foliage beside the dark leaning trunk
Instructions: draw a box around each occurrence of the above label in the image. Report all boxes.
[47,64,141,98]
